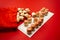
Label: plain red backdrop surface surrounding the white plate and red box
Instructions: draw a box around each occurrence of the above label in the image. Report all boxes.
[0,0,60,40]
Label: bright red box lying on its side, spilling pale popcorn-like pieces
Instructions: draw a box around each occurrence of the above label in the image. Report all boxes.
[0,8,17,28]
